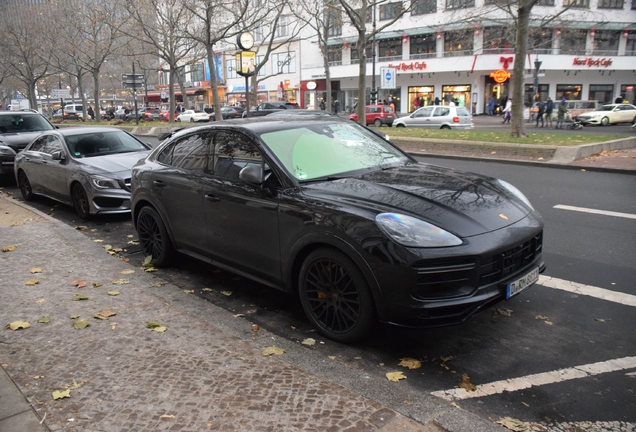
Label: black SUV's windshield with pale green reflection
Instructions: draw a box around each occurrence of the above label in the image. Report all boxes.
[261,123,410,181]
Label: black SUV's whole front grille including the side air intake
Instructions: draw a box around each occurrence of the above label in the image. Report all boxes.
[413,232,543,300]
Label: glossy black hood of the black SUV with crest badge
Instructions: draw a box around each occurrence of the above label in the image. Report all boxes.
[303,164,532,237]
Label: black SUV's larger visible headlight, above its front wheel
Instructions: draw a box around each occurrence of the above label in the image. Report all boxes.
[375,213,462,247]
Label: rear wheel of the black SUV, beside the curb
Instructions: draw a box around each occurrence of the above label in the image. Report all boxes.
[137,206,174,267]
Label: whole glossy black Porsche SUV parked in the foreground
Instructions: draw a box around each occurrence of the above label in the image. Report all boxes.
[132,116,545,343]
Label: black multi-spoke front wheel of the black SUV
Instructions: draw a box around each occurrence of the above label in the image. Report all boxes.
[299,249,375,343]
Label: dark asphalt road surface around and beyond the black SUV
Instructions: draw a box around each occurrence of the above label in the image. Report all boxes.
[4,142,636,431]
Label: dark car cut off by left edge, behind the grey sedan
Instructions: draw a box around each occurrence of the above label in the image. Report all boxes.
[0,110,55,175]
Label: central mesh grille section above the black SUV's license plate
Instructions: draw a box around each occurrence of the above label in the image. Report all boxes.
[480,232,543,285]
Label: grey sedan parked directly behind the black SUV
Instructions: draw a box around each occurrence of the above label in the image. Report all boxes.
[14,127,150,219]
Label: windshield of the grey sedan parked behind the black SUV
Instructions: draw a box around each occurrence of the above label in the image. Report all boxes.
[66,131,148,158]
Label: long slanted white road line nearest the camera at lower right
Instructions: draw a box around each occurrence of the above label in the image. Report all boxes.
[431,357,636,401]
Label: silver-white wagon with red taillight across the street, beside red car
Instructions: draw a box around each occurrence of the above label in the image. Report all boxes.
[393,105,475,129]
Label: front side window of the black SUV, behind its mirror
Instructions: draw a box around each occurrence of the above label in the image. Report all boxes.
[213,131,263,181]
